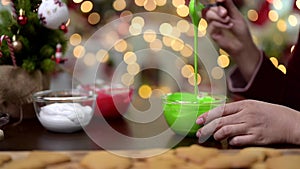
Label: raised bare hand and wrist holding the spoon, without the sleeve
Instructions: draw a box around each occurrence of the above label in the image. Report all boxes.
[204,0,261,81]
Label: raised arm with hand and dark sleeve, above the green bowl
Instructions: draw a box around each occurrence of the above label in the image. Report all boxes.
[204,0,300,110]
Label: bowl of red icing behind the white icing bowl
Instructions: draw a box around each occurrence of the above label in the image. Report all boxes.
[96,87,133,118]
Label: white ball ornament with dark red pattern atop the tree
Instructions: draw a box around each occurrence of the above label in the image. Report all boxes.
[38,0,69,29]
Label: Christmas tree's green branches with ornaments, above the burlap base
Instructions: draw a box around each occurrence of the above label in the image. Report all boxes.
[0,0,69,73]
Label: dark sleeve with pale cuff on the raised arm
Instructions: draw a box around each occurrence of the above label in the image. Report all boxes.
[228,30,300,110]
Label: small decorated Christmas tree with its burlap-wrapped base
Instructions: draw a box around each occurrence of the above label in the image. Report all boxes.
[0,0,68,120]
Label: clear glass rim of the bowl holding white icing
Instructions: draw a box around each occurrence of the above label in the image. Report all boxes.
[32,89,97,102]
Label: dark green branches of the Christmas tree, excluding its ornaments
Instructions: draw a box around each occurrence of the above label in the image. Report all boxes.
[0,0,67,73]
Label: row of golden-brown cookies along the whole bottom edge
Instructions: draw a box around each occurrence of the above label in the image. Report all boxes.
[0,145,300,169]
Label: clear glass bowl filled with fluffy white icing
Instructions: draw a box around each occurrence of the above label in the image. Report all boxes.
[33,89,96,133]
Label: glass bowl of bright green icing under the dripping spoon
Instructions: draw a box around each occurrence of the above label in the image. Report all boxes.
[162,92,226,137]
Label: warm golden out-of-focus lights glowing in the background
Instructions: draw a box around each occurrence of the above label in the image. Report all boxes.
[69,0,300,99]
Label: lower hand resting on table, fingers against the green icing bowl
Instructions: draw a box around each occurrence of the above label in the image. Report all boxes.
[196,100,300,146]
